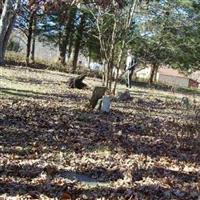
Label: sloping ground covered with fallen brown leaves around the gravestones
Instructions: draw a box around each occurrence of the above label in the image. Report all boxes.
[0,67,200,200]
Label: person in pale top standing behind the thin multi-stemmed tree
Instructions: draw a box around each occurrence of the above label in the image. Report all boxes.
[125,50,137,88]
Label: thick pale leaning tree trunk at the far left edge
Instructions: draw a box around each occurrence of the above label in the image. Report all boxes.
[0,0,21,64]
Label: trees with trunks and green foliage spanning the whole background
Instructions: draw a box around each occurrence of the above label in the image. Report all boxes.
[0,0,200,92]
